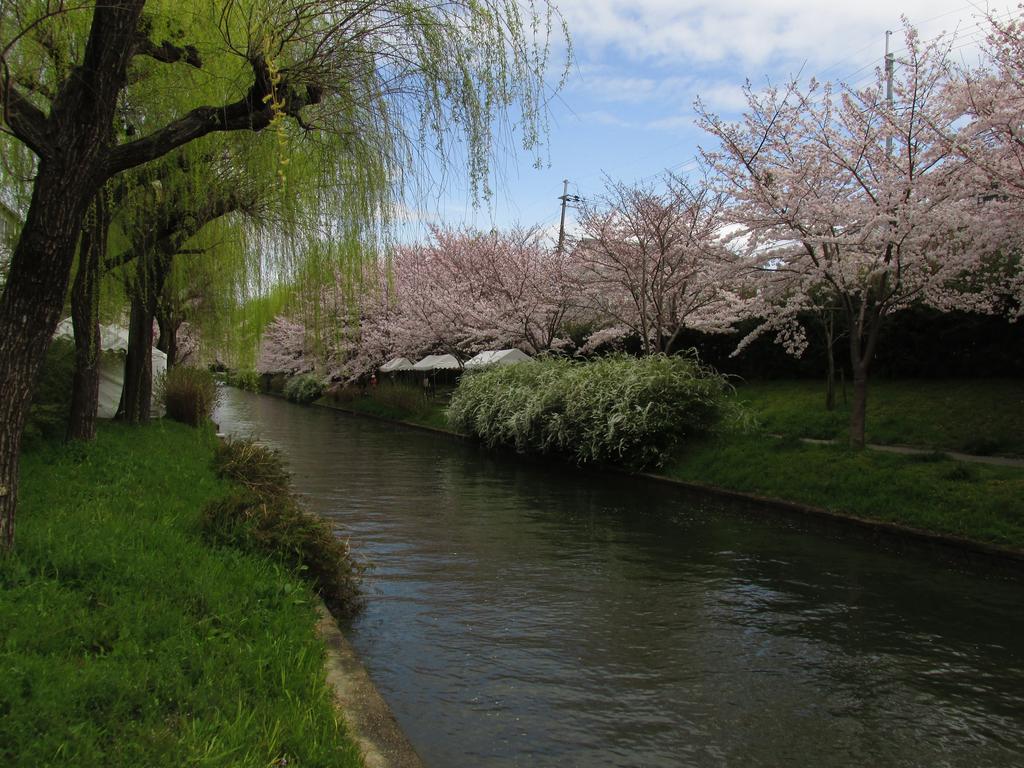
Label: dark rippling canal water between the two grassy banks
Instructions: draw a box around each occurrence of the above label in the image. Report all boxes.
[215,389,1024,768]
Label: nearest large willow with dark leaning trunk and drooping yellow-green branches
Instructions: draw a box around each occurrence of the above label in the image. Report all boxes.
[0,0,569,548]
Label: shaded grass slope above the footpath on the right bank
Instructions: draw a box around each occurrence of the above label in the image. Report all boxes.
[737,379,1024,456]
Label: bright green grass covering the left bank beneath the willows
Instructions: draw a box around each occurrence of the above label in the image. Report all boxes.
[0,423,359,768]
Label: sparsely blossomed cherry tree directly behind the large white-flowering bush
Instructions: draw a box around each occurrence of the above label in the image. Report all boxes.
[572,175,739,353]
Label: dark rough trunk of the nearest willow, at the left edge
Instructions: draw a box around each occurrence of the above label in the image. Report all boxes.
[0,0,144,551]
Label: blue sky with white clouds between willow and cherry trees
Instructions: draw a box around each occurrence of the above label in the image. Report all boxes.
[399,0,1019,240]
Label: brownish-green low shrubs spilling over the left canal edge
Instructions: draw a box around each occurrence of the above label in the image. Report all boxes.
[211,440,361,615]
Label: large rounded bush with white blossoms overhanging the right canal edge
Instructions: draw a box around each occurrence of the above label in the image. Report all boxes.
[449,355,731,468]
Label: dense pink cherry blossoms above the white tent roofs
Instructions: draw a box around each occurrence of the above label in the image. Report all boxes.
[325,228,579,378]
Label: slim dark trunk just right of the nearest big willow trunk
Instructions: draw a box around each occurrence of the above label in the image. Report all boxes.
[68,189,110,440]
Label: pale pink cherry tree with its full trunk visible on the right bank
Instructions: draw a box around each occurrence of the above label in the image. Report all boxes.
[697,28,993,446]
